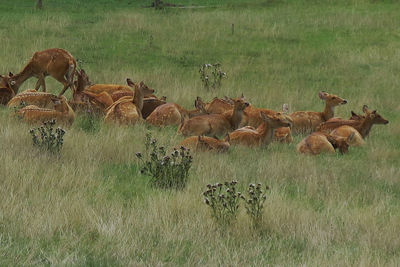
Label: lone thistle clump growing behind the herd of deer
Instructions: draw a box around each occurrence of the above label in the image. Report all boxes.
[199,63,227,90]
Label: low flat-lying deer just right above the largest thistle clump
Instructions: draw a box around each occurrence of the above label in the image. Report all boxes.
[180,135,230,152]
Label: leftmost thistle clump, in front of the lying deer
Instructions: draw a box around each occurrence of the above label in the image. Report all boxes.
[29,120,65,154]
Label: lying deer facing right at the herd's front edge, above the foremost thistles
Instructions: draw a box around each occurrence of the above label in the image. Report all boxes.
[229,112,292,147]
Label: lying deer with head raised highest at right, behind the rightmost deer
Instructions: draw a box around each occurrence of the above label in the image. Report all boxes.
[290,92,347,134]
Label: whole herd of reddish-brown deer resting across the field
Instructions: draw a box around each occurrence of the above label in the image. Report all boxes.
[0,48,389,155]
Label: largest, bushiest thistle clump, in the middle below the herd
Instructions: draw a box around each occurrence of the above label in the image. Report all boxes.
[136,133,193,189]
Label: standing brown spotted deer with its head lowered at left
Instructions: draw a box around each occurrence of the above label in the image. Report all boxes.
[3,48,76,96]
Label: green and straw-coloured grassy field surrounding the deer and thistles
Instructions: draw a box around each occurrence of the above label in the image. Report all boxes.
[0,0,400,266]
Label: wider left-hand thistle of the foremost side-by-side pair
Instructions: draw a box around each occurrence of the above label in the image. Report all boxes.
[203,181,242,225]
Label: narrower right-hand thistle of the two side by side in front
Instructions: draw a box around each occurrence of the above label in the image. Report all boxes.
[241,183,269,227]
